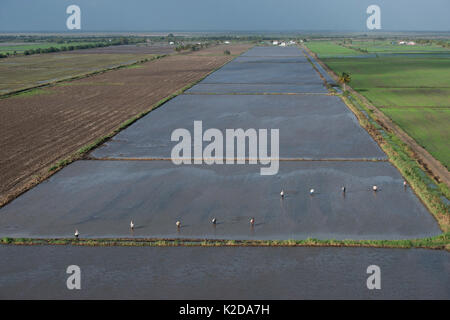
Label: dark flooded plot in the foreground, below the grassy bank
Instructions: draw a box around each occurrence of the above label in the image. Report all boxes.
[0,246,450,299]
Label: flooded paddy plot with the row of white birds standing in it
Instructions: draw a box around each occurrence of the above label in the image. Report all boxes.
[0,161,440,239]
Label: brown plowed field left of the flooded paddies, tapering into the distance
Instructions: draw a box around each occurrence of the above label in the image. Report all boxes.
[0,44,250,206]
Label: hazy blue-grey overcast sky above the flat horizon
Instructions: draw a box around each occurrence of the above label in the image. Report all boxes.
[0,0,450,32]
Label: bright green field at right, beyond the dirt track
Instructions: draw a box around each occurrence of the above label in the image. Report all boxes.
[307,40,450,168]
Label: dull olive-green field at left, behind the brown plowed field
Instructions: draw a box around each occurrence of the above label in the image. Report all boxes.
[0,53,153,93]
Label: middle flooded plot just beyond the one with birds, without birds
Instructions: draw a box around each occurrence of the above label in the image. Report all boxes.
[91,94,386,159]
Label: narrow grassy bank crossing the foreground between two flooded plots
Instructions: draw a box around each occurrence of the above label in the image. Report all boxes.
[0,233,450,251]
